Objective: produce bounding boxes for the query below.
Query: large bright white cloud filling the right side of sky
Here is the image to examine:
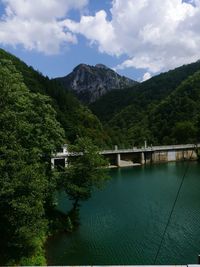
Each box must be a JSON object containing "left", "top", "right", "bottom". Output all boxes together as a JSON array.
[{"left": 63, "top": 0, "right": 200, "bottom": 74}]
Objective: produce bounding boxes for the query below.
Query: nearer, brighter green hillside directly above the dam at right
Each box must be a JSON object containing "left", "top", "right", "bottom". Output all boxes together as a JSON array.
[{"left": 107, "top": 71, "right": 200, "bottom": 147}]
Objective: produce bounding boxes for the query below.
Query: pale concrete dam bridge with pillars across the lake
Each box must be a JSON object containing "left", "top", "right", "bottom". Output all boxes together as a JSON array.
[{"left": 51, "top": 144, "right": 200, "bottom": 167}]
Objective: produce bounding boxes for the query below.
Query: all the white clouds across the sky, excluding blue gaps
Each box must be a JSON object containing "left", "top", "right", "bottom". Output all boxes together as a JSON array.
[{"left": 0, "top": 0, "right": 200, "bottom": 78}]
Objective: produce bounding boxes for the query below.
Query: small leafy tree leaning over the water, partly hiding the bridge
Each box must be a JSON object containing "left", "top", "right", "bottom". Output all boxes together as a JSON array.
[{"left": 62, "top": 138, "right": 108, "bottom": 228}]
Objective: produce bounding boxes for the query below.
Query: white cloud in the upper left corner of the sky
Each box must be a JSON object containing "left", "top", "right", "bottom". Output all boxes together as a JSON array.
[{"left": 0, "top": 0, "right": 88, "bottom": 54}]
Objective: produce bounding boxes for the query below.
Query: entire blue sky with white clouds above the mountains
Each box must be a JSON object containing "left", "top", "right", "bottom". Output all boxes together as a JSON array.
[{"left": 0, "top": 0, "right": 200, "bottom": 81}]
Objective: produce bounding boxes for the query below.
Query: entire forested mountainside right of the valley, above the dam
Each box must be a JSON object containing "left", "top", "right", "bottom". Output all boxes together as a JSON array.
[{"left": 90, "top": 61, "right": 200, "bottom": 147}]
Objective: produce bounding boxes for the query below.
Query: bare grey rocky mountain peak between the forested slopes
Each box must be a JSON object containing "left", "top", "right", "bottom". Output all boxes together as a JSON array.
[{"left": 56, "top": 64, "right": 137, "bottom": 104}]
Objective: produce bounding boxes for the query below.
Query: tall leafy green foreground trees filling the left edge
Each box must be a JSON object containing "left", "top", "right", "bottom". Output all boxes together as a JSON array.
[{"left": 0, "top": 59, "right": 64, "bottom": 265}]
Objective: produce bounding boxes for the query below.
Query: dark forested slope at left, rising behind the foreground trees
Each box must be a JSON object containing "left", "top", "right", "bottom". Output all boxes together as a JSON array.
[{"left": 0, "top": 49, "right": 109, "bottom": 146}]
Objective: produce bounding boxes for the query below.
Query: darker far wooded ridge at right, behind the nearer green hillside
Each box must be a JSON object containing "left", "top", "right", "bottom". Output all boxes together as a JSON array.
[{"left": 89, "top": 61, "right": 200, "bottom": 121}]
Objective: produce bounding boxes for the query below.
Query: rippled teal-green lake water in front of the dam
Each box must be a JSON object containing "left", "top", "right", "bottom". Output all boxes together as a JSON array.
[{"left": 47, "top": 162, "right": 200, "bottom": 265}]
